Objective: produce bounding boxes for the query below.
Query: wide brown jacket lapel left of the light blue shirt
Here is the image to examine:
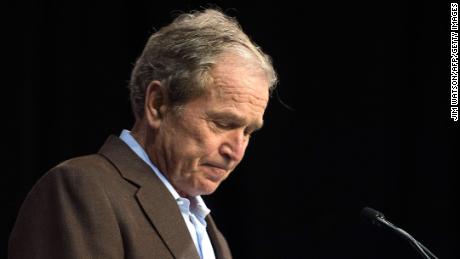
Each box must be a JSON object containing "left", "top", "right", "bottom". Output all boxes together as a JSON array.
[{"left": 99, "top": 136, "right": 199, "bottom": 259}]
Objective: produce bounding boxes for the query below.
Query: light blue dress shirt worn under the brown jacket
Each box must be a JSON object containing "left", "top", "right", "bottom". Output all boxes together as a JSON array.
[{"left": 120, "top": 130, "right": 216, "bottom": 259}]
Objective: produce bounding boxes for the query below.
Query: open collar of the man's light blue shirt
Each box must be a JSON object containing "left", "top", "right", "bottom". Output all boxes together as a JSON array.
[{"left": 120, "top": 129, "right": 211, "bottom": 221}]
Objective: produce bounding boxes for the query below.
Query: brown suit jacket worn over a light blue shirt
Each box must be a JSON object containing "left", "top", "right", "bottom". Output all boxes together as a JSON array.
[{"left": 8, "top": 136, "right": 231, "bottom": 259}]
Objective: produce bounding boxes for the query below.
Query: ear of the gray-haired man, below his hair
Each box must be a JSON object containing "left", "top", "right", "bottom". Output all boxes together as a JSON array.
[{"left": 144, "top": 80, "right": 168, "bottom": 129}]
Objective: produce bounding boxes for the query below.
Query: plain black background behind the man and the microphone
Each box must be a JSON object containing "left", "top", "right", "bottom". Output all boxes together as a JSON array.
[{"left": 0, "top": 0, "right": 460, "bottom": 258}]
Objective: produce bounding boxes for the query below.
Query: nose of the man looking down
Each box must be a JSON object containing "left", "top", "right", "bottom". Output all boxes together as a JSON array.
[{"left": 219, "top": 130, "right": 249, "bottom": 163}]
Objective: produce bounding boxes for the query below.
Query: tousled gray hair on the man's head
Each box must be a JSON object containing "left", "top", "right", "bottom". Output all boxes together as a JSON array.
[{"left": 129, "top": 9, "right": 277, "bottom": 118}]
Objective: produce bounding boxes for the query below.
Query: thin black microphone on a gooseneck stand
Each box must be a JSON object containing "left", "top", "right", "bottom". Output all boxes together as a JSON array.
[{"left": 361, "top": 207, "right": 439, "bottom": 259}]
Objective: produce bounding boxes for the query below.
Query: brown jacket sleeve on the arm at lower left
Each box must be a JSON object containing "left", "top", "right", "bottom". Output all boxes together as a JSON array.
[{"left": 8, "top": 164, "right": 124, "bottom": 259}]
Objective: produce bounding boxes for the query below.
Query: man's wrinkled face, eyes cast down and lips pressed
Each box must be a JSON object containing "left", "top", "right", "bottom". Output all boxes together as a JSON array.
[{"left": 149, "top": 55, "right": 269, "bottom": 196}]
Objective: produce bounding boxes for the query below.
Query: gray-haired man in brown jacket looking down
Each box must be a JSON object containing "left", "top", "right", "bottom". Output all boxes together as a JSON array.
[{"left": 9, "top": 10, "right": 276, "bottom": 259}]
